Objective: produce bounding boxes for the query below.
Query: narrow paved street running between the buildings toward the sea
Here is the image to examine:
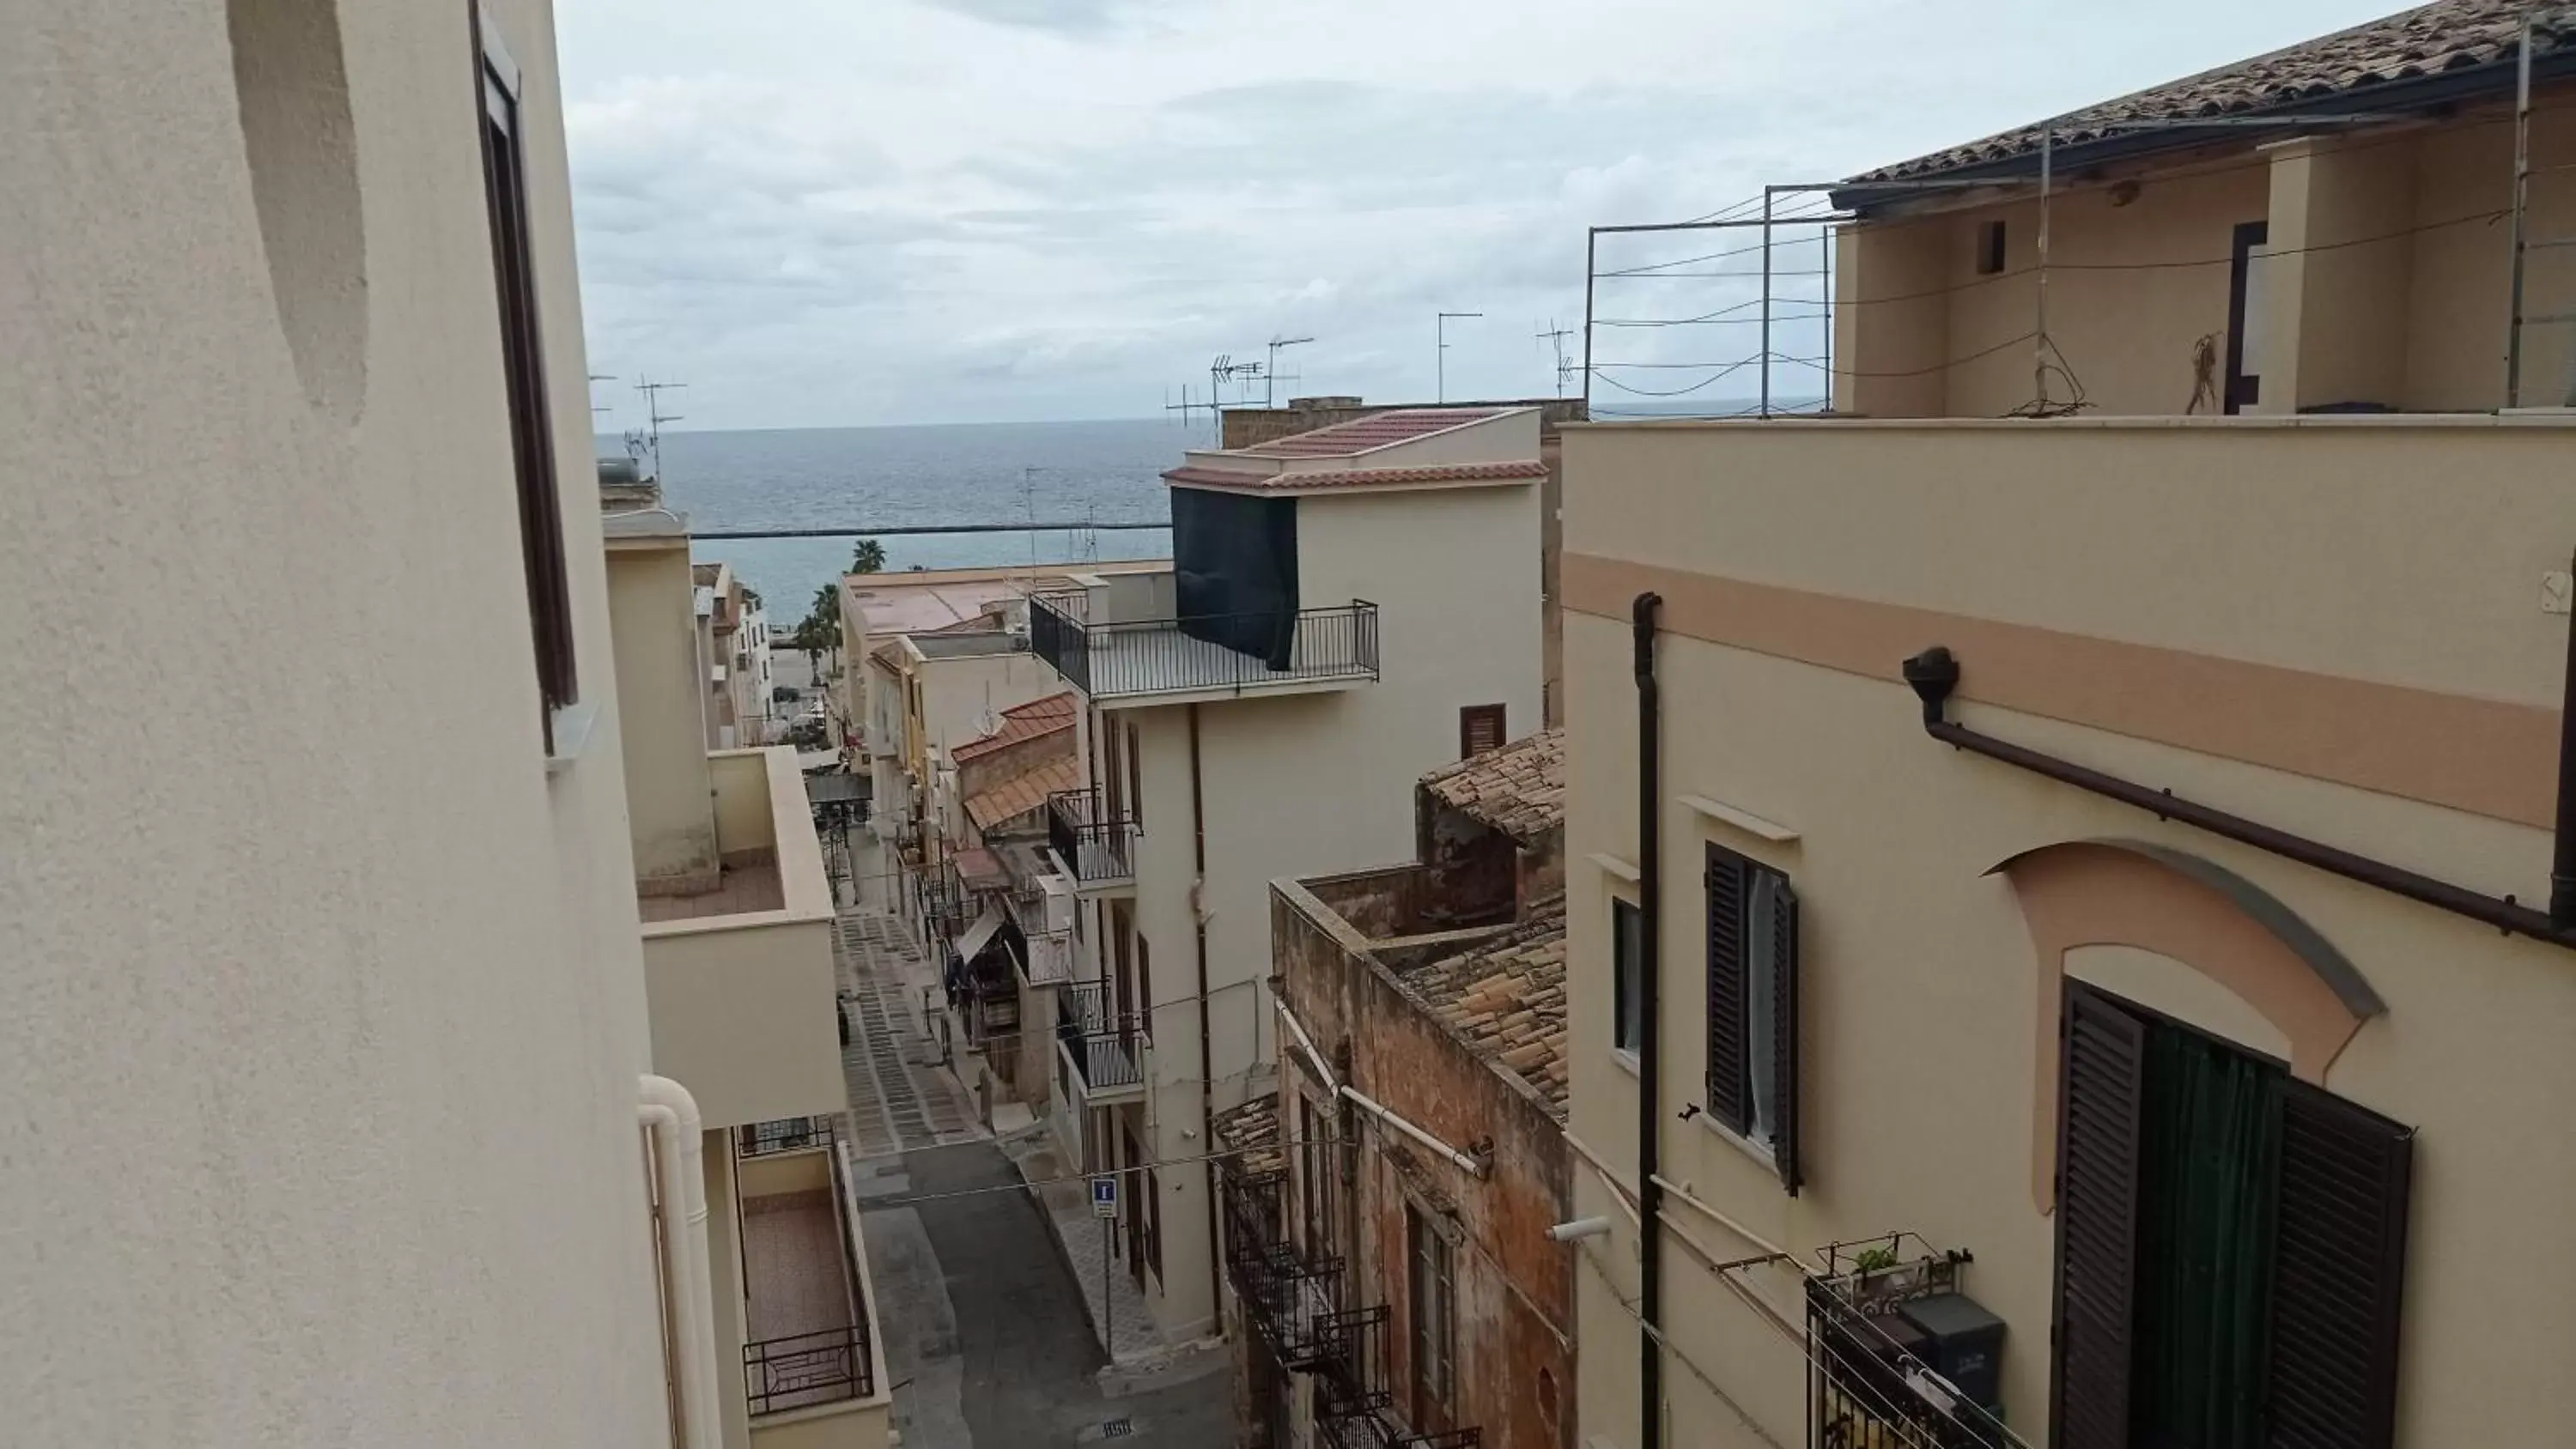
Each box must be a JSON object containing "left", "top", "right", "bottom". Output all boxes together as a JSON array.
[{"left": 837, "top": 911, "right": 1234, "bottom": 1449}]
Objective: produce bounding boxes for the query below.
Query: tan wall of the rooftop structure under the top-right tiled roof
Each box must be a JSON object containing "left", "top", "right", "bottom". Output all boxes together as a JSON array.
[{"left": 1834, "top": 88, "right": 2576, "bottom": 417}]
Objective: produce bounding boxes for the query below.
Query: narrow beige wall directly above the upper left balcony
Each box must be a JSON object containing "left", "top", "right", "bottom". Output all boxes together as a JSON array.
[{"left": 608, "top": 538, "right": 716, "bottom": 885}]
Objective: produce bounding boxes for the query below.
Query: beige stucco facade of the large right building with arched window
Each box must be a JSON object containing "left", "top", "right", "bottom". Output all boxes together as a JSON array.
[{"left": 1566, "top": 422, "right": 2576, "bottom": 1446}]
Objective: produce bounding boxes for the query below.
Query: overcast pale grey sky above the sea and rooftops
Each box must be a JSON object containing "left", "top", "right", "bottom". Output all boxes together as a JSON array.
[{"left": 556, "top": 0, "right": 2396, "bottom": 427}]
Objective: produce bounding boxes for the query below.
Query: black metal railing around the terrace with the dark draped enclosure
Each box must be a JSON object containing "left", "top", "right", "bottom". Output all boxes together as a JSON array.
[{"left": 1028, "top": 595, "right": 1378, "bottom": 700}]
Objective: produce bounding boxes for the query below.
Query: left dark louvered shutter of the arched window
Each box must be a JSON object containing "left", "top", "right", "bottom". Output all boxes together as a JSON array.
[{"left": 2048, "top": 980, "right": 2146, "bottom": 1449}]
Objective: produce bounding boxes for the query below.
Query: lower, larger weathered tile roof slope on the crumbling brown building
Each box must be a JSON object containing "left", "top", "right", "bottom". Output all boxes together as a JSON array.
[{"left": 1401, "top": 895, "right": 1569, "bottom": 1122}]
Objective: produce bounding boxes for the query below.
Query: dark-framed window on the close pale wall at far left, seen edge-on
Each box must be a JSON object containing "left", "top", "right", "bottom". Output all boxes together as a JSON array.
[{"left": 474, "top": 13, "right": 580, "bottom": 754}]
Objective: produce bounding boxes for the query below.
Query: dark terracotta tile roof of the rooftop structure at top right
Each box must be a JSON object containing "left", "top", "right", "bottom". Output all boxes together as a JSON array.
[{"left": 1852, "top": 0, "right": 2576, "bottom": 185}]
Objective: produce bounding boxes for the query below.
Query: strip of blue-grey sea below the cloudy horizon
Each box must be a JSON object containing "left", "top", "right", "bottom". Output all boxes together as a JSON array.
[{"left": 600, "top": 420, "right": 1208, "bottom": 628}]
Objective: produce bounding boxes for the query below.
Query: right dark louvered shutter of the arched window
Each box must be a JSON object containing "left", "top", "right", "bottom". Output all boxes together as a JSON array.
[{"left": 2269, "top": 1081, "right": 2414, "bottom": 1449}]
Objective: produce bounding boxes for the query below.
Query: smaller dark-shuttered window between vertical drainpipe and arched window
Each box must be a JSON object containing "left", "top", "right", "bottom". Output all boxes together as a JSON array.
[{"left": 1705, "top": 844, "right": 1801, "bottom": 1194}]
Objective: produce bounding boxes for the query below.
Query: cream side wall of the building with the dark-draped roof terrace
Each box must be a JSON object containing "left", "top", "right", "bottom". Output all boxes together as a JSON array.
[{"left": 1110, "top": 476, "right": 1540, "bottom": 1328}]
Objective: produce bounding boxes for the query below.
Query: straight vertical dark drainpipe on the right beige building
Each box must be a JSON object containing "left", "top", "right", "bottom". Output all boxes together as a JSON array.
[{"left": 1633, "top": 592, "right": 1664, "bottom": 1449}]
